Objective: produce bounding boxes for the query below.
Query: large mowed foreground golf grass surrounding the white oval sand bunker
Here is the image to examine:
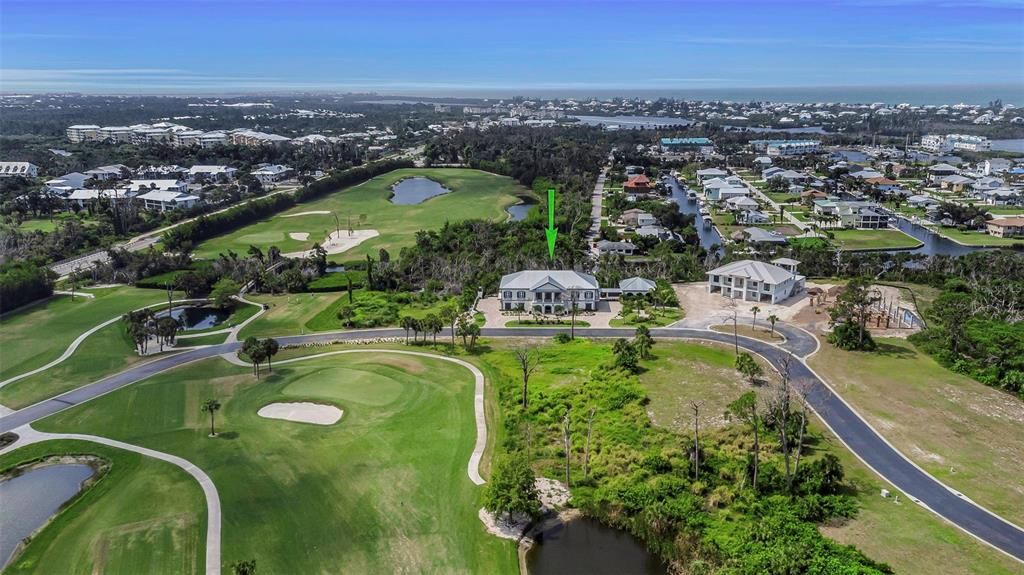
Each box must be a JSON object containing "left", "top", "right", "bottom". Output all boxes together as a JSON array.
[{"left": 38, "top": 352, "right": 518, "bottom": 573}]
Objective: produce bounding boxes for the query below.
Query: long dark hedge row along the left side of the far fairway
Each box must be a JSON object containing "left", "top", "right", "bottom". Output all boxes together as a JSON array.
[{"left": 164, "top": 161, "right": 413, "bottom": 250}]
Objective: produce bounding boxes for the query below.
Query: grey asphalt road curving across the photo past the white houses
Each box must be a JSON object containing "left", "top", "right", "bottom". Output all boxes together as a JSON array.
[{"left": 0, "top": 327, "right": 1024, "bottom": 562}]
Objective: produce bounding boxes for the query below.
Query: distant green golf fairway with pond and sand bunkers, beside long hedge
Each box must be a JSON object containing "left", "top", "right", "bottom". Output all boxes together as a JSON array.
[{"left": 196, "top": 168, "right": 532, "bottom": 259}]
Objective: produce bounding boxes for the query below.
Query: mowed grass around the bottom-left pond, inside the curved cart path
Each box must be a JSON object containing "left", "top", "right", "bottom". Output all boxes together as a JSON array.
[{"left": 0, "top": 440, "right": 206, "bottom": 575}]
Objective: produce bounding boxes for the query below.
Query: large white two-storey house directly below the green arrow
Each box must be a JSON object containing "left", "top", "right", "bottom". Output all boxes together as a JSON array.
[{"left": 498, "top": 270, "right": 601, "bottom": 314}]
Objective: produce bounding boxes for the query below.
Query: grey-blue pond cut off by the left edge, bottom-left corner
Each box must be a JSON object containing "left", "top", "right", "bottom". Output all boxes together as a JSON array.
[{"left": 0, "top": 463, "right": 94, "bottom": 565}]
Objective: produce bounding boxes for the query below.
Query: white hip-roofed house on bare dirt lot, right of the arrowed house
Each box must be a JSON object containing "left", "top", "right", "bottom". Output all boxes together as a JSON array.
[{"left": 708, "top": 258, "right": 805, "bottom": 304}]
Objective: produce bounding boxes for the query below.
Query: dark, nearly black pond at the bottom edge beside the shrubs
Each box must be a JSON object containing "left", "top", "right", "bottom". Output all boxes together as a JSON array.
[{"left": 526, "top": 519, "right": 668, "bottom": 575}]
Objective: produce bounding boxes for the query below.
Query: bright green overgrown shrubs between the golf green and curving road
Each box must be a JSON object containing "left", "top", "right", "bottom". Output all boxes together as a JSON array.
[{"left": 487, "top": 333, "right": 892, "bottom": 575}]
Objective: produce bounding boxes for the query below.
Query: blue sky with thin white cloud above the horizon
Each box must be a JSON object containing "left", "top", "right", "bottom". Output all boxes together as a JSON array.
[{"left": 0, "top": 0, "right": 1024, "bottom": 94}]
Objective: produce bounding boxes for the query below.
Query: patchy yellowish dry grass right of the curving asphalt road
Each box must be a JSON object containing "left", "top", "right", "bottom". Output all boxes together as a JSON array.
[{"left": 809, "top": 339, "right": 1024, "bottom": 525}]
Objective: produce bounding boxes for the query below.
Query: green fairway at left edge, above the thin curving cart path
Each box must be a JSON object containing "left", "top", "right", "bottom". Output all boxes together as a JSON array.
[{"left": 0, "top": 286, "right": 183, "bottom": 381}]
